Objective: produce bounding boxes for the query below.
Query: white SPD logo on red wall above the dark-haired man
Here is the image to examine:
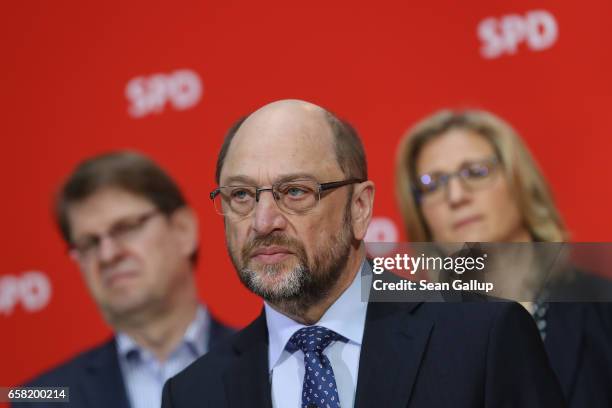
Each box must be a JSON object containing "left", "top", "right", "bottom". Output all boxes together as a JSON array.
[{"left": 125, "top": 69, "right": 203, "bottom": 118}]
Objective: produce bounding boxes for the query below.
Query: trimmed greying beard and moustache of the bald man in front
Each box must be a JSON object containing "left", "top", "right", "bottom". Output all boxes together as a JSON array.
[{"left": 228, "top": 201, "right": 354, "bottom": 315}]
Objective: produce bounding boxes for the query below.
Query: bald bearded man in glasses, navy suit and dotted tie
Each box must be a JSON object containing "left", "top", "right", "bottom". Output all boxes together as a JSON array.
[{"left": 162, "top": 100, "right": 564, "bottom": 408}]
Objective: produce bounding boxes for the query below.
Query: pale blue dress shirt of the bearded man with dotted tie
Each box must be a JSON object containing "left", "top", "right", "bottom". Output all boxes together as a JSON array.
[{"left": 264, "top": 261, "right": 368, "bottom": 408}]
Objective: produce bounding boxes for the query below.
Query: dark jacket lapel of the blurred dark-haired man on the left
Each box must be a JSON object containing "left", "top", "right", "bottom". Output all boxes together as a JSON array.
[{"left": 79, "top": 339, "right": 130, "bottom": 408}]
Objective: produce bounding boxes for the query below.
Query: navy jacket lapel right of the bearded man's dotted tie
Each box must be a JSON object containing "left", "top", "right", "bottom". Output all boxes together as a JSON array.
[{"left": 355, "top": 303, "right": 433, "bottom": 408}]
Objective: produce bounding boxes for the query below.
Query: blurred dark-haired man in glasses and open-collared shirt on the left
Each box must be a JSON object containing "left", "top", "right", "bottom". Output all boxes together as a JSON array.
[{"left": 18, "top": 152, "right": 231, "bottom": 408}]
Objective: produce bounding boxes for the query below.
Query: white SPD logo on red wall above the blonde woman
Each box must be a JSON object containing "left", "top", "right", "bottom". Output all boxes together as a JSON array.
[{"left": 478, "top": 10, "right": 559, "bottom": 59}]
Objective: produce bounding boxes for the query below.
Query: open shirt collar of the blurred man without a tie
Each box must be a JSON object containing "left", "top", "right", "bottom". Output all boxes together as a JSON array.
[{"left": 115, "top": 305, "right": 210, "bottom": 360}]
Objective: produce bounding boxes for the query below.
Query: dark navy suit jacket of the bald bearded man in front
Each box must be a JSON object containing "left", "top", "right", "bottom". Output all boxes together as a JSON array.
[{"left": 162, "top": 302, "right": 565, "bottom": 408}]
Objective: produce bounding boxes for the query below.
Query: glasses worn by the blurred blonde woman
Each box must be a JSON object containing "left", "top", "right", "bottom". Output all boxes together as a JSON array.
[{"left": 414, "top": 157, "right": 499, "bottom": 206}]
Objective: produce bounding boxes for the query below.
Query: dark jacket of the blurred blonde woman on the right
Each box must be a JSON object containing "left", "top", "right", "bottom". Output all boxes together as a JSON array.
[{"left": 426, "top": 256, "right": 612, "bottom": 408}]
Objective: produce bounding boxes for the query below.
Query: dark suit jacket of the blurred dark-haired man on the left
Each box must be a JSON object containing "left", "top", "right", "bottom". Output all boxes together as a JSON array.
[{"left": 13, "top": 317, "right": 234, "bottom": 408}]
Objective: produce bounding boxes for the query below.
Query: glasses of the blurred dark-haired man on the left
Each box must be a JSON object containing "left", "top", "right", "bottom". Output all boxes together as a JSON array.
[{"left": 70, "top": 209, "right": 161, "bottom": 262}]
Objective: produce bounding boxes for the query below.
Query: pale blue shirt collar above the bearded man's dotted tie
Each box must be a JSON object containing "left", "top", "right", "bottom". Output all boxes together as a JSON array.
[{"left": 264, "top": 260, "right": 368, "bottom": 371}]
